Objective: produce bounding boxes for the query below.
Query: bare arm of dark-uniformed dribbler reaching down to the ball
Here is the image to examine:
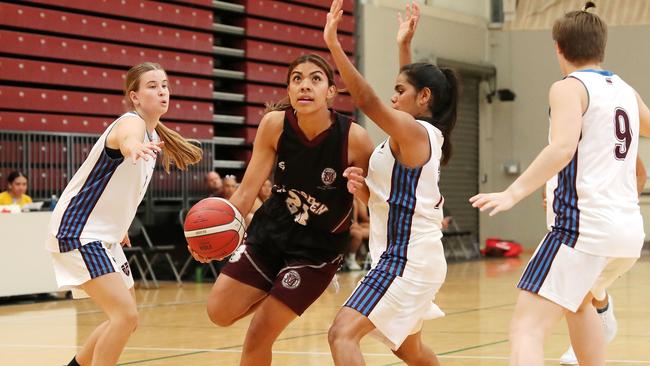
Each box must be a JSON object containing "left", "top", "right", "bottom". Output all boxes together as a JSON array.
[{"left": 230, "top": 111, "right": 284, "bottom": 217}]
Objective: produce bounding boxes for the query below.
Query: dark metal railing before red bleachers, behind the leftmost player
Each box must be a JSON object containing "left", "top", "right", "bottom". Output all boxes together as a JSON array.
[{"left": 0, "top": 131, "right": 214, "bottom": 207}]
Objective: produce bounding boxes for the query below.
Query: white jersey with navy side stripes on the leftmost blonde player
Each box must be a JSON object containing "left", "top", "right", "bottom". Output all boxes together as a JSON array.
[{"left": 46, "top": 113, "right": 158, "bottom": 253}]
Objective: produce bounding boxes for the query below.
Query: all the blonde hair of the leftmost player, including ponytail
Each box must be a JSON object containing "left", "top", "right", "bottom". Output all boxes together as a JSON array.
[{"left": 124, "top": 62, "right": 203, "bottom": 173}]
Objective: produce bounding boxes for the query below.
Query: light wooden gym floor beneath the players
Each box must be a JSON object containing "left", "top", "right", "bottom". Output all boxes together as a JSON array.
[{"left": 0, "top": 257, "right": 650, "bottom": 366}]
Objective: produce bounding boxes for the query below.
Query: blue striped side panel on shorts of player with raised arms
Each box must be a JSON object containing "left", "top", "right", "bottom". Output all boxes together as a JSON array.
[{"left": 344, "top": 269, "right": 397, "bottom": 316}]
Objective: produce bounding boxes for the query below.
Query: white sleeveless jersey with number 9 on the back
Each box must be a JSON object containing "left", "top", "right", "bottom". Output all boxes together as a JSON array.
[{"left": 546, "top": 70, "right": 645, "bottom": 257}]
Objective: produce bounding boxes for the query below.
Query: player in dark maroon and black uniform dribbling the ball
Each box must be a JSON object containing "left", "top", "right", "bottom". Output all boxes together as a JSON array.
[{"left": 187, "top": 55, "right": 373, "bottom": 366}]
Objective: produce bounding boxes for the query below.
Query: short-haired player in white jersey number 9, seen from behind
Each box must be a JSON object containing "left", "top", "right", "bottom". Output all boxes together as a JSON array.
[{"left": 470, "top": 2, "right": 650, "bottom": 366}]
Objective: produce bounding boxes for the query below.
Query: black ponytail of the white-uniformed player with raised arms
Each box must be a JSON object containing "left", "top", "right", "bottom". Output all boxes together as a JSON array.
[{"left": 433, "top": 68, "right": 460, "bottom": 165}]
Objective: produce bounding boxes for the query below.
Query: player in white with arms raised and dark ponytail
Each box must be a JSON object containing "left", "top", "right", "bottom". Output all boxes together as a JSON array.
[{"left": 324, "top": 0, "right": 458, "bottom": 366}]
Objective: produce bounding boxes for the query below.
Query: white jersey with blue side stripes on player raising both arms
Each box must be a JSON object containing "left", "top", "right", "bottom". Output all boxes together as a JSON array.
[{"left": 366, "top": 121, "right": 443, "bottom": 268}]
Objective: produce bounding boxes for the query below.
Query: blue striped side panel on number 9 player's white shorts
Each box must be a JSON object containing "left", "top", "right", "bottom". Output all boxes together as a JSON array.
[{"left": 517, "top": 231, "right": 563, "bottom": 294}]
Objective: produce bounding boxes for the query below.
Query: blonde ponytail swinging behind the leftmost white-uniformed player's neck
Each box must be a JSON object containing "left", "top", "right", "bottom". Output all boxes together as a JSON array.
[{"left": 156, "top": 122, "right": 203, "bottom": 173}]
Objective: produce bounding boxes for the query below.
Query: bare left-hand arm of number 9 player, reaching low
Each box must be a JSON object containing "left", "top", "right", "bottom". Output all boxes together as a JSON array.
[{"left": 469, "top": 78, "right": 587, "bottom": 216}]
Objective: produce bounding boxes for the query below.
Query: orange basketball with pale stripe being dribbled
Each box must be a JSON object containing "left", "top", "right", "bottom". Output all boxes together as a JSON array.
[{"left": 183, "top": 197, "right": 246, "bottom": 259}]
